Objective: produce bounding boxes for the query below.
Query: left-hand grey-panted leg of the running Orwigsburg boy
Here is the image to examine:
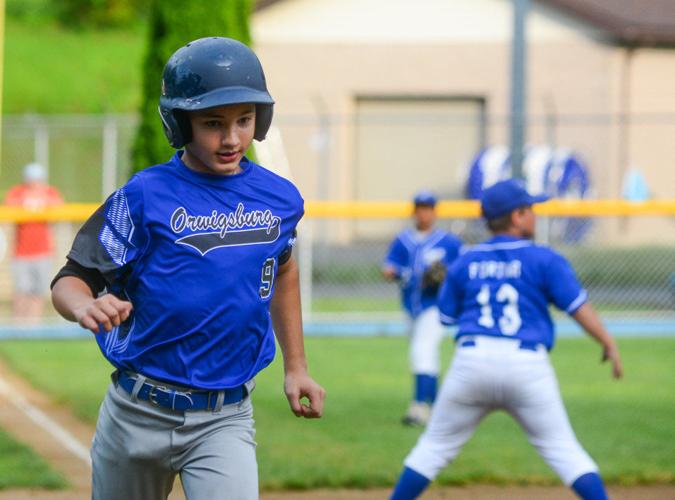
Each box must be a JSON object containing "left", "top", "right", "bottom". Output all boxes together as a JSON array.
[{"left": 91, "top": 385, "right": 177, "bottom": 500}]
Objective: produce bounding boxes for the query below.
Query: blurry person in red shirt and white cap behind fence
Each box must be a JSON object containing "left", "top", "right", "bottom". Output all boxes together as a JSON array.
[{"left": 5, "top": 163, "right": 63, "bottom": 318}]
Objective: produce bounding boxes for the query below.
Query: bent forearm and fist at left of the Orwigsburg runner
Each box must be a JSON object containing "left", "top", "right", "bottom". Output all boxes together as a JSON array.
[{"left": 52, "top": 276, "right": 132, "bottom": 333}]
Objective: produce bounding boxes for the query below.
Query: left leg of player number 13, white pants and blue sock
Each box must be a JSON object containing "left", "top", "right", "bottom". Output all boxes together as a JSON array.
[{"left": 391, "top": 355, "right": 489, "bottom": 500}]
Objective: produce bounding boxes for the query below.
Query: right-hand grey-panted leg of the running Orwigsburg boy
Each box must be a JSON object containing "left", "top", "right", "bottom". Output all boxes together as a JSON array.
[{"left": 174, "top": 397, "right": 258, "bottom": 500}]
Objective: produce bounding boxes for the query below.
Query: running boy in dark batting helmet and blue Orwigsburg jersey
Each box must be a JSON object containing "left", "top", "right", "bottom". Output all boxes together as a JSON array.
[{"left": 52, "top": 37, "right": 325, "bottom": 500}]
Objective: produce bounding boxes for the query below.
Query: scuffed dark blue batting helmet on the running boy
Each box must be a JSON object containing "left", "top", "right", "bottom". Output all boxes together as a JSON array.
[{"left": 159, "top": 37, "right": 274, "bottom": 149}]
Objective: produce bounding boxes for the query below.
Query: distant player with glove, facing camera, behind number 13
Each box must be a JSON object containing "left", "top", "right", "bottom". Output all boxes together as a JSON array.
[{"left": 382, "top": 191, "right": 462, "bottom": 425}]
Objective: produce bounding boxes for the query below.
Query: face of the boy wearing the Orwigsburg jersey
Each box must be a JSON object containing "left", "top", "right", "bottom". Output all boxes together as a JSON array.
[{"left": 183, "top": 104, "right": 255, "bottom": 175}]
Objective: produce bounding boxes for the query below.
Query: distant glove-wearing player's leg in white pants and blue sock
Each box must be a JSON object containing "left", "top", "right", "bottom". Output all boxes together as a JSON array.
[{"left": 403, "top": 307, "right": 443, "bottom": 425}]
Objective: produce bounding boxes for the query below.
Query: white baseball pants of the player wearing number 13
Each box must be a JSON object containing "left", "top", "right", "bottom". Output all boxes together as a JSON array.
[{"left": 405, "top": 335, "right": 598, "bottom": 485}]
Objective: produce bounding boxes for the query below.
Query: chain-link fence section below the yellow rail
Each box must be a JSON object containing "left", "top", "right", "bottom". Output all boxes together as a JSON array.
[{"left": 0, "top": 209, "right": 675, "bottom": 334}]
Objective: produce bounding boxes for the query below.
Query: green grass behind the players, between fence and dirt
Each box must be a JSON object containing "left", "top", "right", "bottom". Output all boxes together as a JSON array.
[{"left": 0, "top": 338, "right": 675, "bottom": 489}]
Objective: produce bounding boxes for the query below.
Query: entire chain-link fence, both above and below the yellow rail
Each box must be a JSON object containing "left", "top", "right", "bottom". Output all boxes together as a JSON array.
[{"left": 0, "top": 111, "right": 675, "bottom": 329}]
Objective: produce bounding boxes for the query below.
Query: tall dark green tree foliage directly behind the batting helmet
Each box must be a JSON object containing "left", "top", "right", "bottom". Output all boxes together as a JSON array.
[{"left": 131, "top": 0, "right": 252, "bottom": 172}]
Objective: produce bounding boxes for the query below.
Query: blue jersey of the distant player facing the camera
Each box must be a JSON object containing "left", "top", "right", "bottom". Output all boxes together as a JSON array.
[{"left": 384, "top": 228, "right": 462, "bottom": 318}]
